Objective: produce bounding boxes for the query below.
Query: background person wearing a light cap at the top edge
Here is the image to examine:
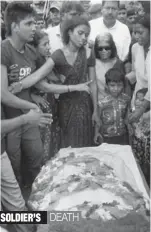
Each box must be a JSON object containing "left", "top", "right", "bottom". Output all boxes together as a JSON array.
[{"left": 47, "top": 1, "right": 61, "bottom": 28}]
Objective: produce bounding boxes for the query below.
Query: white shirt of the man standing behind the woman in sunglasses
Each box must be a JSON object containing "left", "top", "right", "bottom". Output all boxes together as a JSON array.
[{"left": 89, "top": 17, "right": 131, "bottom": 61}]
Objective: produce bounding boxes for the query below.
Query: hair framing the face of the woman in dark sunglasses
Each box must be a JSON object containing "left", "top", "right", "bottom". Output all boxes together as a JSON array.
[{"left": 94, "top": 33, "right": 117, "bottom": 59}]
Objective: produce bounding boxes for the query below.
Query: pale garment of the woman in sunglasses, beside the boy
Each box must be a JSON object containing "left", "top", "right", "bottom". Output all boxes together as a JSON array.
[{"left": 95, "top": 59, "right": 116, "bottom": 101}]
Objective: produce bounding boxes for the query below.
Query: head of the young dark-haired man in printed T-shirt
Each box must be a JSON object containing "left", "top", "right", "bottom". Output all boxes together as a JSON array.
[{"left": 4, "top": 2, "right": 36, "bottom": 42}]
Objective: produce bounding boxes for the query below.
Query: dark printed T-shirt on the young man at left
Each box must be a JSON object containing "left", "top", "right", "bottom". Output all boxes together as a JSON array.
[{"left": 1, "top": 39, "right": 37, "bottom": 118}]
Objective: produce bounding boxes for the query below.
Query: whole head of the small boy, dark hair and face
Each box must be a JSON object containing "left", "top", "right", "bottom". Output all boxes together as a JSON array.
[{"left": 105, "top": 68, "right": 125, "bottom": 98}]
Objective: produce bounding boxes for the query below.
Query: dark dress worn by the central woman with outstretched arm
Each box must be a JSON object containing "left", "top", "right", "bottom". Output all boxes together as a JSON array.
[{"left": 52, "top": 48, "right": 95, "bottom": 147}]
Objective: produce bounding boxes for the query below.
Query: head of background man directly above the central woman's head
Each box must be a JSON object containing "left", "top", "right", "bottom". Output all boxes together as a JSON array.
[{"left": 60, "top": 1, "right": 85, "bottom": 21}]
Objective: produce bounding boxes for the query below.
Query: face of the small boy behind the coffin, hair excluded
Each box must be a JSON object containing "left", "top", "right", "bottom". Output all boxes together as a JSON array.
[{"left": 107, "top": 81, "right": 124, "bottom": 97}]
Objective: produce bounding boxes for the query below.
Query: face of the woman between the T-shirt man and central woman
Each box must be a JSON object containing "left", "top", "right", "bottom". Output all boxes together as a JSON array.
[{"left": 38, "top": 35, "right": 50, "bottom": 57}]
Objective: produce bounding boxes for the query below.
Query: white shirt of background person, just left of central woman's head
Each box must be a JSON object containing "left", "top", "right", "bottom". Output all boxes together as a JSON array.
[{"left": 45, "top": 24, "right": 63, "bottom": 53}]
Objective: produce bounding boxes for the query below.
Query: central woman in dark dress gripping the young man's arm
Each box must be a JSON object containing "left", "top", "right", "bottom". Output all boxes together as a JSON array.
[{"left": 10, "top": 16, "right": 98, "bottom": 147}]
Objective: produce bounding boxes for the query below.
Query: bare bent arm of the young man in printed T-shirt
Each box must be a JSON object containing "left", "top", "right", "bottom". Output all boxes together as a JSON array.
[{"left": 1, "top": 65, "right": 38, "bottom": 109}]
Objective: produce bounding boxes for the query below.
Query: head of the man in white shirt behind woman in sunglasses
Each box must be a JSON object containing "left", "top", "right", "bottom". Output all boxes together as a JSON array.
[{"left": 102, "top": 0, "right": 119, "bottom": 24}]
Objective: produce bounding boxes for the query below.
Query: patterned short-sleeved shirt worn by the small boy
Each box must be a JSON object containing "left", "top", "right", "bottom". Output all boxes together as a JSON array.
[{"left": 99, "top": 93, "right": 130, "bottom": 138}]
